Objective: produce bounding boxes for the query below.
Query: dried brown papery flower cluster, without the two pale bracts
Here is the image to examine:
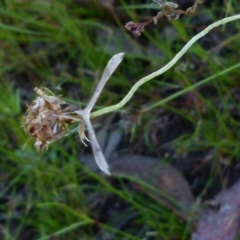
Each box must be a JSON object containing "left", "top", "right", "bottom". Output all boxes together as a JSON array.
[{"left": 23, "top": 87, "right": 73, "bottom": 151}]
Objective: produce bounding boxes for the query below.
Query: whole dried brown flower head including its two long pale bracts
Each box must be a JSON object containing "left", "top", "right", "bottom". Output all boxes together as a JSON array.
[{"left": 22, "top": 53, "right": 124, "bottom": 174}]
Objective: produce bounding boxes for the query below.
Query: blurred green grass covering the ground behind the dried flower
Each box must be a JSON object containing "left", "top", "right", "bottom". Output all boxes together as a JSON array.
[{"left": 0, "top": 0, "right": 240, "bottom": 240}]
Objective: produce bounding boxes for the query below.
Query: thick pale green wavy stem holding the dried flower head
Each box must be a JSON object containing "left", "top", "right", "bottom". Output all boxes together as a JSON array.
[{"left": 91, "top": 14, "right": 240, "bottom": 118}]
